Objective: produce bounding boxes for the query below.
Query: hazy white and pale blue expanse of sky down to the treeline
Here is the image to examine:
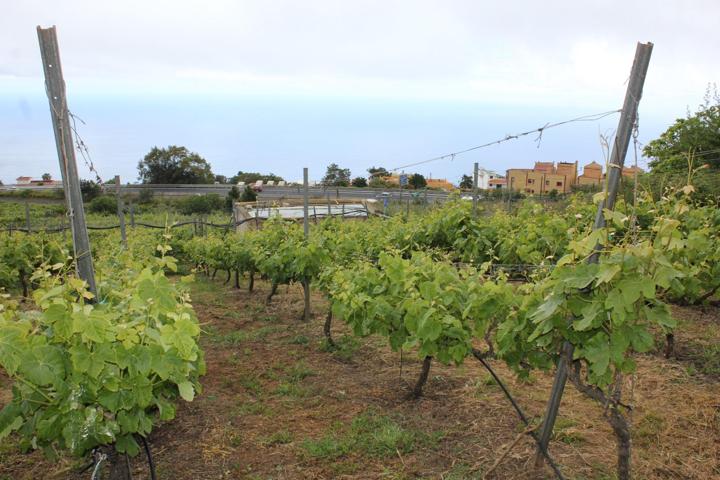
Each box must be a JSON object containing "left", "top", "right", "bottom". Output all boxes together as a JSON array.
[{"left": 0, "top": 0, "right": 720, "bottom": 184}]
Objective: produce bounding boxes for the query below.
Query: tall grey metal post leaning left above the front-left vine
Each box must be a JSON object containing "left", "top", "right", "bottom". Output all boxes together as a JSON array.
[{"left": 37, "top": 26, "right": 97, "bottom": 298}]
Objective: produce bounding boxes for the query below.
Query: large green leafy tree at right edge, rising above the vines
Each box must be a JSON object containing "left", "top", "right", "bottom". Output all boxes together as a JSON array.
[{"left": 643, "top": 87, "right": 720, "bottom": 174}]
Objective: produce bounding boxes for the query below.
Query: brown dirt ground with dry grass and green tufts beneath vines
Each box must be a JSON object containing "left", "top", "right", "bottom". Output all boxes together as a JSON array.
[{"left": 0, "top": 277, "right": 720, "bottom": 480}]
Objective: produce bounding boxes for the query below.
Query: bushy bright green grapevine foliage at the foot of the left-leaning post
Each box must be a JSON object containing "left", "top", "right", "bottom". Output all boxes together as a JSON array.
[{"left": 0, "top": 247, "right": 205, "bottom": 455}]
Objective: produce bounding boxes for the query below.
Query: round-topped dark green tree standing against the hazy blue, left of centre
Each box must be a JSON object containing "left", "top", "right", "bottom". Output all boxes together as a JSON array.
[{"left": 138, "top": 145, "right": 215, "bottom": 184}]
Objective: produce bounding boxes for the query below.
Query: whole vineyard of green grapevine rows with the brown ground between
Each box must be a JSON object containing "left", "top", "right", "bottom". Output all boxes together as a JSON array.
[{"left": 0, "top": 186, "right": 720, "bottom": 478}]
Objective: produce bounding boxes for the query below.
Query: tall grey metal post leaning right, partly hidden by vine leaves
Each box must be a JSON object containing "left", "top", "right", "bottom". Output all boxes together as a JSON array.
[{"left": 536, "top": 42, "right": 653, "bottom": 465}]
